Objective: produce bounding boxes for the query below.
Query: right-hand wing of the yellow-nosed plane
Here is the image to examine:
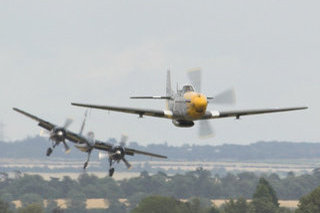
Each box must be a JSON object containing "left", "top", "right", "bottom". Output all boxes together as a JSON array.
[{"left": 203, "top": 107, "right": 308, "bottom": 119}]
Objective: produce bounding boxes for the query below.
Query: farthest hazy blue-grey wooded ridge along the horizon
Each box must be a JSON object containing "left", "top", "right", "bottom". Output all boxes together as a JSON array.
[{"left": 0, "top": 137, "right": 320, "bottom": 161}]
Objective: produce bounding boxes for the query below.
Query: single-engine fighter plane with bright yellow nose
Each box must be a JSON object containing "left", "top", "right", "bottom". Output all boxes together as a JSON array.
[{"left": 72, "top": 68, "right": 307, "bottom": 137}]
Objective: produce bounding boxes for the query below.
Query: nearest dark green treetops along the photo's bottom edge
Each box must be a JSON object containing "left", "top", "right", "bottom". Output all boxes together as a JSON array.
[{"left": 0, "top": 177, "right": 320, "bottom": 213}]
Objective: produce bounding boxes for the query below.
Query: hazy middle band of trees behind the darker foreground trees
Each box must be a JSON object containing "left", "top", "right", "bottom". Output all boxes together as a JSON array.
[{"left": 0, "top": 168, "right": 320, "bottom": 212}]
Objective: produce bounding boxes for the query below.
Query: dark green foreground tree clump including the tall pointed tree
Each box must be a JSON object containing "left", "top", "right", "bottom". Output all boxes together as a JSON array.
[{"left": 132, "top": 178, "right": 294, "bottom": 213}]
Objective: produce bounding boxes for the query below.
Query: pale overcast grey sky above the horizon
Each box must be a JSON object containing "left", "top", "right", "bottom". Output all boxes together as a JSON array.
[{"left": 0, "top": 0, "right": 320, "bottom": 145}]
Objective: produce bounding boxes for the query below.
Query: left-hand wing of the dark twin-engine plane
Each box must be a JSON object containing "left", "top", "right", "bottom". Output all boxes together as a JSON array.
[{"left": 13, "top": 108, "right": 87, "bottom": 143}]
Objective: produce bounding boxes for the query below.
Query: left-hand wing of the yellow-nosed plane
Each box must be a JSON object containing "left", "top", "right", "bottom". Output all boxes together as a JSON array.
[{"left": 71, "top": 103, "right": 172, "bottom": 118}]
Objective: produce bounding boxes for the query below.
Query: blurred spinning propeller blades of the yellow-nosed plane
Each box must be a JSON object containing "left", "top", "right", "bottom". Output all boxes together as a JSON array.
[{"left": 188, "top": 68, "right": 236, "bottom": 138}]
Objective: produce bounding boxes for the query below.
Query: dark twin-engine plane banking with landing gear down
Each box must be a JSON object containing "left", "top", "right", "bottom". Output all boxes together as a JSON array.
[{"left": 13, "top": 108, "right": 167, "bottom": 176}]
